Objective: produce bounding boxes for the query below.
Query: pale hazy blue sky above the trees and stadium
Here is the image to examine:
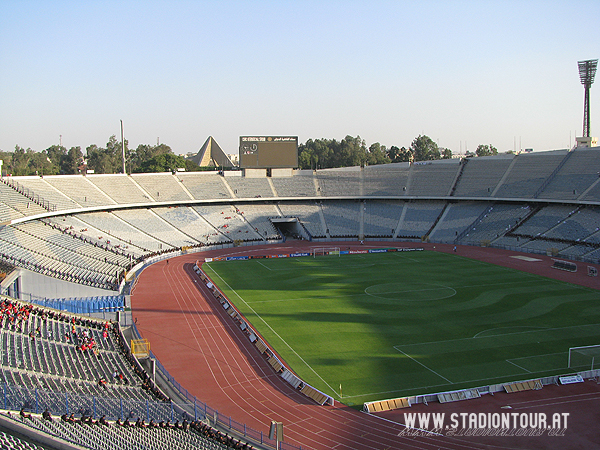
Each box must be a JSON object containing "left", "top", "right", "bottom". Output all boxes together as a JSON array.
[{"left": 0, "top": 0, "right": 600, "bottom": 158}]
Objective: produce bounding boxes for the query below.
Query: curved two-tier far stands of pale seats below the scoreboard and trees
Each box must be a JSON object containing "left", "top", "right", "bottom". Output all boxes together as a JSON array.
[{"left": 0, "top": 149, "right": 600, "bottom": 298}]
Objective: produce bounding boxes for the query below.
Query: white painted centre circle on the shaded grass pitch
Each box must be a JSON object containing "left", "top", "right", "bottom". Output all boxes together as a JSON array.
[{"left": 365, "top": 281, "right": 456, "bottom": 302}]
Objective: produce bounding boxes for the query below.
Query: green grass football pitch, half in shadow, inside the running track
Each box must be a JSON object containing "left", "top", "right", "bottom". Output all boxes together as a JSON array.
[{"left": 203, "top": 251, "right": 600, "bottom": 405}]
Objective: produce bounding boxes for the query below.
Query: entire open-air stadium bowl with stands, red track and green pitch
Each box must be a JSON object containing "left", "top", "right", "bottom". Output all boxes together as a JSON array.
[{"left": 0, "top": 147, "right": 600, "bottom": 449}]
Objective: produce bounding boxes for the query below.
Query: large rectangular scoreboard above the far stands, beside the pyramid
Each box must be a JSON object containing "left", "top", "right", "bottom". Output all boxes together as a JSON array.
[{"left": 240, "top": 136, "right": 298, "bottom": 169}]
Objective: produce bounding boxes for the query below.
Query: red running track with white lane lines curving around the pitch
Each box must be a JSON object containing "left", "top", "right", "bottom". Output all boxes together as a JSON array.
[{"left": 131, "top": 242, "right": 598, "bottom": 450}]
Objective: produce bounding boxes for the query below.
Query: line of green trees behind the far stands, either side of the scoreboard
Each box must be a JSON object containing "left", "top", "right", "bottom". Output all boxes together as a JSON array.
[{"left": 0, "top": 135, "right": 498, "bottom": 176}]
